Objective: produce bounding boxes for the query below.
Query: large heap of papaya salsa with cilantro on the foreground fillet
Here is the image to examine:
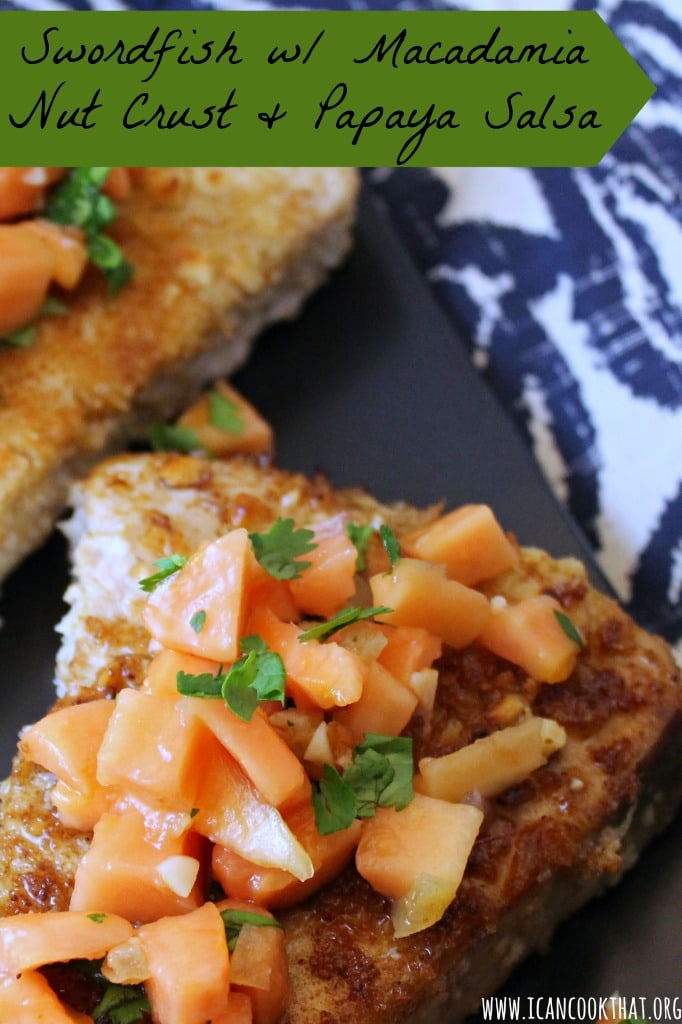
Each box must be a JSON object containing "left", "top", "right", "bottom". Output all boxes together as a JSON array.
[{"left": 0, "top": 505, "right": 582, "bottom": 1024}]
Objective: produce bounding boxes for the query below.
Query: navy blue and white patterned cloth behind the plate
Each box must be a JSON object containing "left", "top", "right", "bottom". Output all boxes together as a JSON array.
[{"left": 6, "top": 0, "right": 682, "bottom": 658}]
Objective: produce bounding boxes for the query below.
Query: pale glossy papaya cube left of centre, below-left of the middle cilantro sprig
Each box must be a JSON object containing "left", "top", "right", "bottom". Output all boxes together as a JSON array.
[{"left": 97, "top": 689, "right": 207, "bottom": 810}]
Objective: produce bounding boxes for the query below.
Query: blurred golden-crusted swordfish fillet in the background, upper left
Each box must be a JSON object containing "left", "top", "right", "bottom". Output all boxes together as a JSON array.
[{"left": 0, "top": 167, "right": 357, "bottom": 580}]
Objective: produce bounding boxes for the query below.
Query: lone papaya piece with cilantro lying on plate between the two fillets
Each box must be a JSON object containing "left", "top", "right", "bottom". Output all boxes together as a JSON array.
[{"left": 178, "top": 381, "right": 273, "bottom": 458}]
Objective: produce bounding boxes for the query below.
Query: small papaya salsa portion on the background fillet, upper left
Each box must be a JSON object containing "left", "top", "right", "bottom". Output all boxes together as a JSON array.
[{"left": 0, "top": 167, "right": 131, "bottom": 347}]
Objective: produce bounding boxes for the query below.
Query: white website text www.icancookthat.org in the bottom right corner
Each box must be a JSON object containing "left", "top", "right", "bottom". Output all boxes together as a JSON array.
[{"left": 481, "top": 995, "right": 682, "bottom": 1024}]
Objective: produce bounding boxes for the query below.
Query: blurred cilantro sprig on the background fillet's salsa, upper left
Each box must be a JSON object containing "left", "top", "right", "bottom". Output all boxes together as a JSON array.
[{"left": 44, "top": 167, "right": 132, "bottom": 293}]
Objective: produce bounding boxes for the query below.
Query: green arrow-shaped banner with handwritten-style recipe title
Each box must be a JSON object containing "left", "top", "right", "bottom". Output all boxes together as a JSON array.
[{"left": 0, "top": 11, "right": 654, "bottom": 167}]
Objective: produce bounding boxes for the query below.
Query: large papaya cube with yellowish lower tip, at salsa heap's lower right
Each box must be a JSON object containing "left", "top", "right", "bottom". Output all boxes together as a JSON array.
[{"left": 355, "top": 794, "right": 483, "bottom": 935}]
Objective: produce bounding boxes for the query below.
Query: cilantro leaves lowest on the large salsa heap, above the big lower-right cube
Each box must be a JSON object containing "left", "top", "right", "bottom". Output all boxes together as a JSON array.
[{"left": 312, "top": 733, "right": 414, "bottom": 836}]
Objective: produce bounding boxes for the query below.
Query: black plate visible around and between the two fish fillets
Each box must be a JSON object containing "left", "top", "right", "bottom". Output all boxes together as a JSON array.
[{"left": 0, "top": 192, "right": 682, "bottom": 1020}]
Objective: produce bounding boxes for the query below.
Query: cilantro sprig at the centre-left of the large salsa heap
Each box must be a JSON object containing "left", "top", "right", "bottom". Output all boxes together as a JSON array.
[{"left": 176, "top": 634, "right": 287, "bottom": 722}]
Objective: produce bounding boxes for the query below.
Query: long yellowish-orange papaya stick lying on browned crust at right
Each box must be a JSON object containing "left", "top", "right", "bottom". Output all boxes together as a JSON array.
[{"left": 415, "top": 717, "right": 566, "bottom": 802}]
